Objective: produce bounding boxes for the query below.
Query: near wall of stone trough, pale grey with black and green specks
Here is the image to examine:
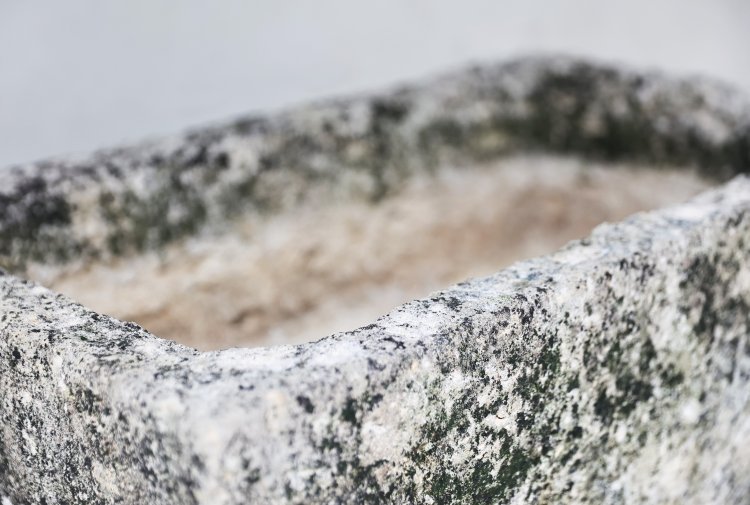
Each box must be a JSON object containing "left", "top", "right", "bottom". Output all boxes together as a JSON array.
[{"left": 0, "top": 178, "right": 750, "bottom": 504}]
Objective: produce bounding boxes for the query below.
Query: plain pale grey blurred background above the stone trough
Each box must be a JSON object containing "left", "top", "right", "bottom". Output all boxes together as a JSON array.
[{"left": 0, "top": 0, "right": 750, "bottom": 166}]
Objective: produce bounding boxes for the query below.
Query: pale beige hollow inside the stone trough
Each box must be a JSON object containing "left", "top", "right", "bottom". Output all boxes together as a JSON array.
[{"left": 36, "top": 157, "right": 710, "bottom": 349}]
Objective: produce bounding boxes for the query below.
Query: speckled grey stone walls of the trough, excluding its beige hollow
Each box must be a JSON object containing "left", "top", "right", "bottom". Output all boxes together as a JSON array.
[{"left": 0, "top": 59, "right": 750, "bottom": 505}]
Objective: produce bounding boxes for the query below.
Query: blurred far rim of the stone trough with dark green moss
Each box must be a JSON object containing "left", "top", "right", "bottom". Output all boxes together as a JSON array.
[{"left": 0, "top": 57, "right": 750, "bottom": 272}]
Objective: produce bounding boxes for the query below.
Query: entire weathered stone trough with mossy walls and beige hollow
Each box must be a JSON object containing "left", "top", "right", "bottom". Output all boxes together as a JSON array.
[{"left": 0, "top": 57, "right": 750, "bottom": 505}]
